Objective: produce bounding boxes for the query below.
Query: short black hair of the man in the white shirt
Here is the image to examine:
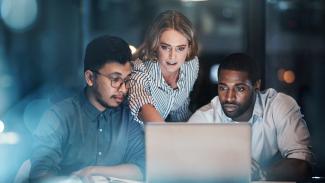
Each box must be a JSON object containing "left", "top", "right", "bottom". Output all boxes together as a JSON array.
[{"left": 218, "top": 53, "right": 261, "bottom": 84}]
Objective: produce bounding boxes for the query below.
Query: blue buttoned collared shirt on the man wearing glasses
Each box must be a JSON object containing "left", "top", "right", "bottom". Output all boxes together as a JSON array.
[{"left": 30, "top": 92, "right": 144, "bottom": 179}]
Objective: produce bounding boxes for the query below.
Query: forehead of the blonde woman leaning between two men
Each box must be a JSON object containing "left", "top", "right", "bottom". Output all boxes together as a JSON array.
[{"left": 159, "top": 29, "right": 188, "bottom": 46}]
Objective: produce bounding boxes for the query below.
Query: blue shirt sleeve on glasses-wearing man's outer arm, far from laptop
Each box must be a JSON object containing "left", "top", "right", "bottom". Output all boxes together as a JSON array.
[{"left": 30, "top": 109, "right": 67, "bottom": 180}]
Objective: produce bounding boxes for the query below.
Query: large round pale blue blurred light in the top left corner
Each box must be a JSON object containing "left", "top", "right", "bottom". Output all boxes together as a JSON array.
[{"left": 0, "top": 0, "right": 38, "bottom": 31}]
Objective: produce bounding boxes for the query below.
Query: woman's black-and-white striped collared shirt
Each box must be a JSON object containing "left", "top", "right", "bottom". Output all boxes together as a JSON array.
[{"left": 129, "top": 57, "right": 199, "bottom": 123}]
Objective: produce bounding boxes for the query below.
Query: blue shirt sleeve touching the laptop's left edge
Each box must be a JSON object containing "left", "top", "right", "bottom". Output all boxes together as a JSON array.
[{"left": 126, "top": 118, "right": 145, "bottom": 175}]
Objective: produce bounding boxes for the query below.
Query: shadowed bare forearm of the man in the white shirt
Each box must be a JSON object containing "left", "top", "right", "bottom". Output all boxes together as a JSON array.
[{"left": 265, "top": 158, "right": 312, "bottom": 181}]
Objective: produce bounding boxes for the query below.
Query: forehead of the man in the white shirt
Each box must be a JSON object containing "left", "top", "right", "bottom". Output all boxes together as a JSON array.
[{"left": 219, "top": 69, "right": 251, "bottom": 84}]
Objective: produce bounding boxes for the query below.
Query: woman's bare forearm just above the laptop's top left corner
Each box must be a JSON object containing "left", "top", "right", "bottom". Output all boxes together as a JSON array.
[{"left": 138, "top": 104, "right": 165, "bottom": 122}]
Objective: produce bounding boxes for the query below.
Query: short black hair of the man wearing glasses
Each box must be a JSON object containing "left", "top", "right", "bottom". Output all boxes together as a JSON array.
[{"left": 84, "top": 35, "right": 132, "bottom": 71}]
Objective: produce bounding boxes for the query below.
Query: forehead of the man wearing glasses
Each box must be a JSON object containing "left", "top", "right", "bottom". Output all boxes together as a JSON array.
[{"left": 99, "top": 62, "right": 132, "bottom": 77}]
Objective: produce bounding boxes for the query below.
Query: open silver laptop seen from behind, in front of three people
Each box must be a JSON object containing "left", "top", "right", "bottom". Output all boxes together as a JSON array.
[{"left": 145, "top": 122, "right": 251, "bottom": 183}]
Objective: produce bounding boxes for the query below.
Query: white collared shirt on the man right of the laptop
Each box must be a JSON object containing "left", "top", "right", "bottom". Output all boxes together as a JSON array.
[{"left": 189, "top": 89, "right": 313, "bottom": 166}]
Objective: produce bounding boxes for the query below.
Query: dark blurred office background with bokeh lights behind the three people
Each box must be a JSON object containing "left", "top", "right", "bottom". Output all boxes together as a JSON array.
[{"left": 0, "top": 0, "right": 325, "bottom": 182}]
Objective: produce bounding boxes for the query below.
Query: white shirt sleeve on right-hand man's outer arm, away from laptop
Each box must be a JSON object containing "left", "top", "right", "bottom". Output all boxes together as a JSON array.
[{"left": 273, "top": 93, "right": 314, "bottom": 163}]
